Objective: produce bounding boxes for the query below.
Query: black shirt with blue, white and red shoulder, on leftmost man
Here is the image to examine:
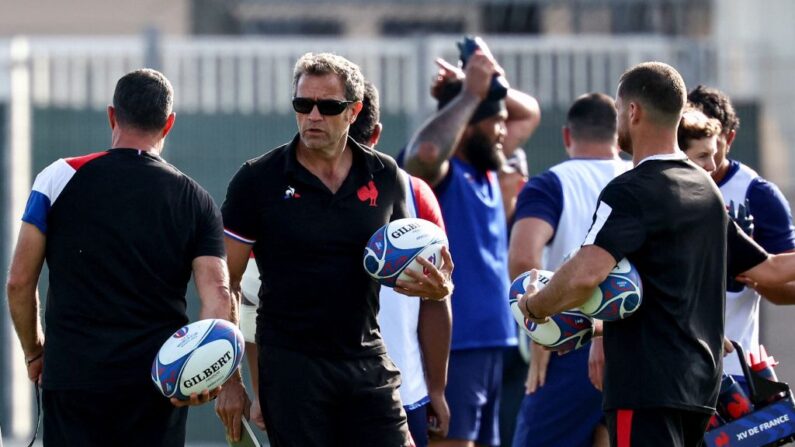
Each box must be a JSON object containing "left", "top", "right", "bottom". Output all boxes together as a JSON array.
[{"left": 22, "top": 149, "right": 225, "bottom": 390}]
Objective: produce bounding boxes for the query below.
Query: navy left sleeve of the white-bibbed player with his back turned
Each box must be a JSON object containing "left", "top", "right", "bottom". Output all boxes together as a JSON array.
[{"left": 514, "top": 171, "right": 563, "bottom": 230}]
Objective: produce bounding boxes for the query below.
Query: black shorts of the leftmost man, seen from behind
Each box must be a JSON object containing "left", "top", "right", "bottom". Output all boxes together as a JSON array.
[{"left": 41, "top": 383, "right": 188, "bottom": 447}]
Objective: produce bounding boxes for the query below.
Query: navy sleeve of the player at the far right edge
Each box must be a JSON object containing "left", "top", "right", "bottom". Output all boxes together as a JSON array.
[{"left": 746, "top": 178, "right": 795, "bottom": 253}]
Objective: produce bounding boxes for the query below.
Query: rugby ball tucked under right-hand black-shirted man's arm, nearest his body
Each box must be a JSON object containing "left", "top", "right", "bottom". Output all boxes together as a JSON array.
[{"left": 580, "top": 258, "right": 643, "bottom": 321}]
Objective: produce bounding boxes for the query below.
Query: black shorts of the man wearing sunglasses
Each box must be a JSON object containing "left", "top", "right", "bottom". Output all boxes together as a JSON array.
[{"left": 259, "top": 346, "right": 409, "bottom": 447}]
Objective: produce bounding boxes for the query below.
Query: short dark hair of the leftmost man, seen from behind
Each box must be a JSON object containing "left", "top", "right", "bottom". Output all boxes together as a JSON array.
[{"left": 113, "top": 68, "right": 174, "bottom": 132}]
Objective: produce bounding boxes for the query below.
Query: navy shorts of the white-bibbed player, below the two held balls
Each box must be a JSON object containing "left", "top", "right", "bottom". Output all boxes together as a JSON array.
[{"left": 513, "top": 345, "right": 604, "bottom": 447}]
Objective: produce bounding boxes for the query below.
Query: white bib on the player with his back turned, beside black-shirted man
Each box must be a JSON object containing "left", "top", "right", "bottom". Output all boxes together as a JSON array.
[{"left": 544, "top": 159, "right": 632, "bottom": 272}]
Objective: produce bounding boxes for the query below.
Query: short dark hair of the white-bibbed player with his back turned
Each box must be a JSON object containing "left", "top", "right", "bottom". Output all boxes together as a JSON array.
[{"left": 566, "top": 93, "right": 616, "bottom": 142}]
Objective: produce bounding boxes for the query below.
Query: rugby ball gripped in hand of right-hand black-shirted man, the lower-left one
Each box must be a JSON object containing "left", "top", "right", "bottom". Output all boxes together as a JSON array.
[{"left": 509, "top": 270, "right": 593, "bottom": 351}]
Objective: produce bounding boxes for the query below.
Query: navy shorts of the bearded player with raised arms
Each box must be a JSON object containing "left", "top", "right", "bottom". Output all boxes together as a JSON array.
[{"left": 444, "top": 348, "right": 505, "bottom": 446}]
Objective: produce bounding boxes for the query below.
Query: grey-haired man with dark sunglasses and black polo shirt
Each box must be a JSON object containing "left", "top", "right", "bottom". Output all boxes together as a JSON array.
[{"left": 222, "top": 53, "right": 409, "bottom": 446}]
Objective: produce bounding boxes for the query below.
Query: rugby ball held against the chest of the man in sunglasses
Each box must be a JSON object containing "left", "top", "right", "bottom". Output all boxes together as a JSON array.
[{"left": 364, "top": 217, "right": 448, "bottom": 287}]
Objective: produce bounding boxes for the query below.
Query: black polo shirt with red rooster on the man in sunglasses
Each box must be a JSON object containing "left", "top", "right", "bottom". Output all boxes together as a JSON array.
[{"left": 222, "top": 136, "right": 407, "bottom": 357}]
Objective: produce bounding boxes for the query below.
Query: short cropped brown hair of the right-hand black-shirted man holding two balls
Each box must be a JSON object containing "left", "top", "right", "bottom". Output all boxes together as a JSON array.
[{"left": 618, "top": 62, "right": 687, "bottom": 125}]
